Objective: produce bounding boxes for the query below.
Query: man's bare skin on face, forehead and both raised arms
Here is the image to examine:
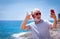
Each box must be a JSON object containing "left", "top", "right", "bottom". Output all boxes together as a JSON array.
[{"left": 21, "top": 10, "right": 57, "bottom": 30}]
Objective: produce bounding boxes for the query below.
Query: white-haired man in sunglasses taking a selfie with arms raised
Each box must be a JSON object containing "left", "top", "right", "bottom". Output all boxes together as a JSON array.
[{"left": 21, "top": 9, "right": 57, "bottom": 39}]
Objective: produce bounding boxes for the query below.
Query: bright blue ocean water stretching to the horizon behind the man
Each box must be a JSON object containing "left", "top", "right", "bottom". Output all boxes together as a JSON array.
[{"left": 0, "top": 20, "right": 53, "bottom": 39}]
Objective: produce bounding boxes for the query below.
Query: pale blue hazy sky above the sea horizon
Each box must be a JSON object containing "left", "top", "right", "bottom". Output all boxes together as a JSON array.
[{"left": 0, "top": 0, "right": 60, "bottom": 20}]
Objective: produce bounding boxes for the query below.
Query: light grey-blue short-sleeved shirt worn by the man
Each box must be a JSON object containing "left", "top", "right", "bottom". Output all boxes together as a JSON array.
[{"left": 27, "top": 19, "right": 51, "bottom": 39}]
